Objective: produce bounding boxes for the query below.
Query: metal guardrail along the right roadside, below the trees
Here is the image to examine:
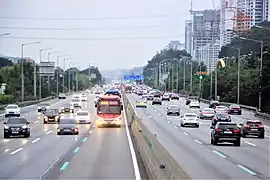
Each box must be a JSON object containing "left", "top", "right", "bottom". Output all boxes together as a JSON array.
[{"left": 179, "top": 94, "right": 270, "bottom": 119}]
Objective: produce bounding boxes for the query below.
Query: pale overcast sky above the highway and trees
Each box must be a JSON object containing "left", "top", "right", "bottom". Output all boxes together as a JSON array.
[{"left": 0, "top": 0, "right": 219, "bottom": 70}]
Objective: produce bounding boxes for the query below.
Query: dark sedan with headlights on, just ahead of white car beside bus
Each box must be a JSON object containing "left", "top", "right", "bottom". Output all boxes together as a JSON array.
[{"left": 57, "top": 117, "right": 79, "bottom": 135}]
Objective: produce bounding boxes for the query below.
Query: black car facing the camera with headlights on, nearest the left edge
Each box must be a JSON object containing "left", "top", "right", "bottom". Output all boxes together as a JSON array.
[{"left": 4, "top": 117, "right": 30, "bottom": 138}]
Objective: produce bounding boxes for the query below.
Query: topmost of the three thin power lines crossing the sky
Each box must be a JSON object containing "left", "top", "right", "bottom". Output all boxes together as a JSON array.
[{"left": 0, "top": 13, "right": 179, "bottom": 20}]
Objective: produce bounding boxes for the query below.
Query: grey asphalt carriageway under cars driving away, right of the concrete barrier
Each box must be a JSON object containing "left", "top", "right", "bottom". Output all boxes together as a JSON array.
[{"left": 128, "top": 94, "right": 270, "bottom": 179}]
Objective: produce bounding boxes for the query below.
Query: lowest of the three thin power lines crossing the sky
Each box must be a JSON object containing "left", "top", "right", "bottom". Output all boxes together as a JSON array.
[{"left": 3, "top": 35, "right": 183, "bottom": 41}]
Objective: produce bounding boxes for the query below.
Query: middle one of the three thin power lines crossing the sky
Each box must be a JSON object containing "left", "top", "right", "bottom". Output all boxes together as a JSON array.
[{"left": 0, "top": 24, "right": 180, "bottom": 31}]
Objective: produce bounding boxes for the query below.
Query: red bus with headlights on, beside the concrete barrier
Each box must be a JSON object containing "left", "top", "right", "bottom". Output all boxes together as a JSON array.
[{"left": 96, "top": 95, "right": 123, "bottom": 127}]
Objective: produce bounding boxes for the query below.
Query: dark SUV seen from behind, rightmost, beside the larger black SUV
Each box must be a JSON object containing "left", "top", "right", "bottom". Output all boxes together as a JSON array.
[{"left": 240, "top": 120, "right": 265, "bottom": 139}]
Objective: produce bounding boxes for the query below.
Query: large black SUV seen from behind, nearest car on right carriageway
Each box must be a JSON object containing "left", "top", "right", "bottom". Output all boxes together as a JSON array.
[{"left": 211, "top": 122, "right": 241, "bottom": 146}]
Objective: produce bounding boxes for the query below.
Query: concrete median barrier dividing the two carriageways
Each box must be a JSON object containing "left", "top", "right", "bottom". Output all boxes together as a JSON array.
[{"left": 123, "top": 93, "right": 191, "bottom": 179}]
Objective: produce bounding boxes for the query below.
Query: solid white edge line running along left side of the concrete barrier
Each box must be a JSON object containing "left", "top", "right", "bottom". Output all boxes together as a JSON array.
[{"left": 123, "top": 94, "right": 141, "bottom": 180}]
